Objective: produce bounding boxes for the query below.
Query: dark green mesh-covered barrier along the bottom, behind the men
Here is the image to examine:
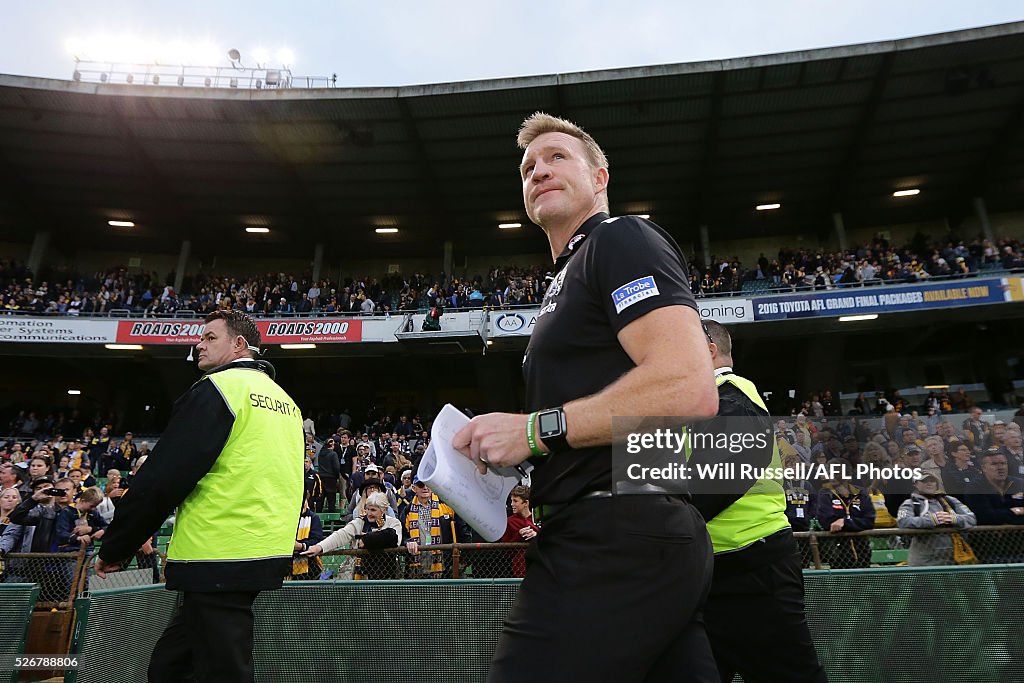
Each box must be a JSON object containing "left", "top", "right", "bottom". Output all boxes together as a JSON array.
[{"left": 59, "top": 565, "right": 1024, "bottom": 683}]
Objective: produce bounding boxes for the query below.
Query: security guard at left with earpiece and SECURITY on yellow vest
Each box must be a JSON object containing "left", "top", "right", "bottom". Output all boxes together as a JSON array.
[{"left": 96, "top": 310, "right": 304, "bottom": 683}]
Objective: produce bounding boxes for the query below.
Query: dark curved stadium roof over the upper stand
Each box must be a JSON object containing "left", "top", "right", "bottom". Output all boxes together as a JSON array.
[{"left": 0, "top": 23, "right": 1024, "bottom": 258}]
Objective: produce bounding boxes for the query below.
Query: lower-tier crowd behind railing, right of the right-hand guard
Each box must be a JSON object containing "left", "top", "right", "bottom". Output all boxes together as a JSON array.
[{"left": 775, "top": 403, "right": 1024, "bottom": 567}]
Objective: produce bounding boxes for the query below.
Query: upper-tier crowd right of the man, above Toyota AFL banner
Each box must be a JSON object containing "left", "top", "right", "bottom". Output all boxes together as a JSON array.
[{"left": 690, "top": 236, "right": 1024, "bottom": 297}]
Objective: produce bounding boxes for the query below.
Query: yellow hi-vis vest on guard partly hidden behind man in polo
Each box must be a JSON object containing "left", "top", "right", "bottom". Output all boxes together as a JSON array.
[{"left": 708, "top": 373, "right": 790, "bottom": 554}]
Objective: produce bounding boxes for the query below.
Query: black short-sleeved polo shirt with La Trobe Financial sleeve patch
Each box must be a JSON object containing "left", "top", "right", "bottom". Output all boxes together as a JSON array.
[{"left": 523, "top": 213, "right": 696, "bottom": 504}]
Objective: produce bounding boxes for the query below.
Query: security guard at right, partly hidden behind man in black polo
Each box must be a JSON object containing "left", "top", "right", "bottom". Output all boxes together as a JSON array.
[{"left": 689, "top": 321, "right": 827, "bottom": 683}]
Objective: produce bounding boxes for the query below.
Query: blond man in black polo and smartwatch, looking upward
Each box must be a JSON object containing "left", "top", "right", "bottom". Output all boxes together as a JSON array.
[{"left": 453, "top": 113, "right": 718, "bottom": 683}]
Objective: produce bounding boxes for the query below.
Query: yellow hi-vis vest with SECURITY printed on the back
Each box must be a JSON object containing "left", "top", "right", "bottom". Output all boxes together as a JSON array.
[{"left": 167, "top": 368, "right": 305, "bottom": 561}]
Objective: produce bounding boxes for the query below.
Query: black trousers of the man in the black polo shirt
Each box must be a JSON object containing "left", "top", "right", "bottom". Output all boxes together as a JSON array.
[{"left": 487, "top": 496, "right": 718, "bottom": 683}]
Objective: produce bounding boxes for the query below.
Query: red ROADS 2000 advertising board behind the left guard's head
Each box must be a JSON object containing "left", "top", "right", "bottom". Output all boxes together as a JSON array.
[{"left": 118, "top": 318, "right": 362, "bottom": 344}]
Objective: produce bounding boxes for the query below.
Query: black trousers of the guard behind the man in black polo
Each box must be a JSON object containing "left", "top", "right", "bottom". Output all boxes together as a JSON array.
[{"left": 705, "top": 529, "right": 827, "bottom": 683}]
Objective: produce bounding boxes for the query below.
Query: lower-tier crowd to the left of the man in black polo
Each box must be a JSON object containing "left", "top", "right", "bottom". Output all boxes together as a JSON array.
[{"left": 0, "top": 411, "right": 537, "bottom": 583}]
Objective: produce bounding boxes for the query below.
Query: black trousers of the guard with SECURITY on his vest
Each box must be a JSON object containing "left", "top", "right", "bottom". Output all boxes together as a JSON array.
[{"left": 148, "top": 591, "right": 259, "bottom": 683}]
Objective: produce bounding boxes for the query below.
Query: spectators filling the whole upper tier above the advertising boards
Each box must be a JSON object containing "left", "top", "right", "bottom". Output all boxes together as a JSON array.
[{"left": 6, "top": 232, "right": 1024, "bottom": 316}]
